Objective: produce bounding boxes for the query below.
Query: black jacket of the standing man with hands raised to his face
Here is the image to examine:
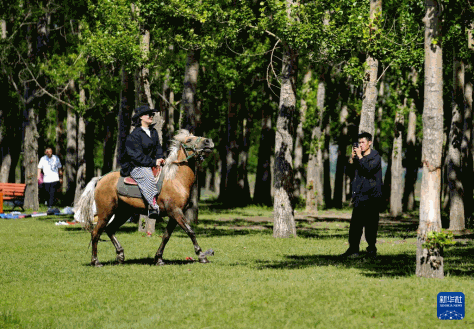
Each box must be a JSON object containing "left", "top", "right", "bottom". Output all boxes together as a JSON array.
[{"left": 352, "top": 150, "right": 382, "bottom": 206}]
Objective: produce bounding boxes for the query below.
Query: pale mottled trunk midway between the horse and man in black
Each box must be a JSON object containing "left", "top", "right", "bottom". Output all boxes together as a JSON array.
[{"left": 273, "top": 43, "right": 297, "bottom": 238}]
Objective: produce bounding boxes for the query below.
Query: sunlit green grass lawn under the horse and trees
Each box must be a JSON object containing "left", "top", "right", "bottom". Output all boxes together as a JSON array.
[{"left": 0, "top": 205, "right": 474, "bottom": 329}]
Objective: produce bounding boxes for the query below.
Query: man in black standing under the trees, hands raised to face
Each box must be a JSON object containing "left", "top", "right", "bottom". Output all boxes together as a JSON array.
[{"left": 341, "top": 132, "right": 382, "bottom": 259}]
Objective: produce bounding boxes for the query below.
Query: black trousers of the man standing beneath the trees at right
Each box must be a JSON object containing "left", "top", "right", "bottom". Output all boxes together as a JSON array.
[{"left": 349, "top": 198, "right": 380, "bottom": 252}]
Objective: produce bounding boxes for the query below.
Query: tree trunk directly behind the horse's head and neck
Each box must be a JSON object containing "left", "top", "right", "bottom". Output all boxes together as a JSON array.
[{"left": 181, "top": 50, "right": 201, "bottom": 224}]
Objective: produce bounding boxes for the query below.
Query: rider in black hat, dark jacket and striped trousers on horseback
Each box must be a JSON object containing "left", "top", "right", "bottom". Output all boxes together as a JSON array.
[{"left": 120, "top": 105, "right": 165, "bottom": 219}]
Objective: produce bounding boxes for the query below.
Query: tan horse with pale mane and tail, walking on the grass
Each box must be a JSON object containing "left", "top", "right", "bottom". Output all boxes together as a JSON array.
[{"left": 76, "top": 130, "right": 214, "bottom": 266}]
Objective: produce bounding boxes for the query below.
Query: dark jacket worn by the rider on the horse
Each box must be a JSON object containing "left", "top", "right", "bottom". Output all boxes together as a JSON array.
[{"left": 120, "top": 126, "right": 164, "bottom": 177}]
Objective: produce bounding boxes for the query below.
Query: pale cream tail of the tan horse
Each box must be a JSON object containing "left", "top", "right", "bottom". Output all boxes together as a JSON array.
[{"left": 74, "top": 177, "right": 101, "bottom": 232}]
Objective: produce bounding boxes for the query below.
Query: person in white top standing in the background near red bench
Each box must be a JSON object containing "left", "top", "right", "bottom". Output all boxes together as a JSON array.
[{"left": 38, "top": 147, "right": 63, "bottom": 209}]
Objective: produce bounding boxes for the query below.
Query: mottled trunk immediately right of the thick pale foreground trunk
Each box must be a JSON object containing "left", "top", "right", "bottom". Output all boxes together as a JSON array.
[{"left": 448, "top": 60, "right": 466, "bottom": 233}]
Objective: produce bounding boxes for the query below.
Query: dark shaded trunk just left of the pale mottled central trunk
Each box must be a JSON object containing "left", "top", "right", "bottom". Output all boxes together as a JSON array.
[{"left": 253, "top": 99, "right": 275, "bottom": 207}]
